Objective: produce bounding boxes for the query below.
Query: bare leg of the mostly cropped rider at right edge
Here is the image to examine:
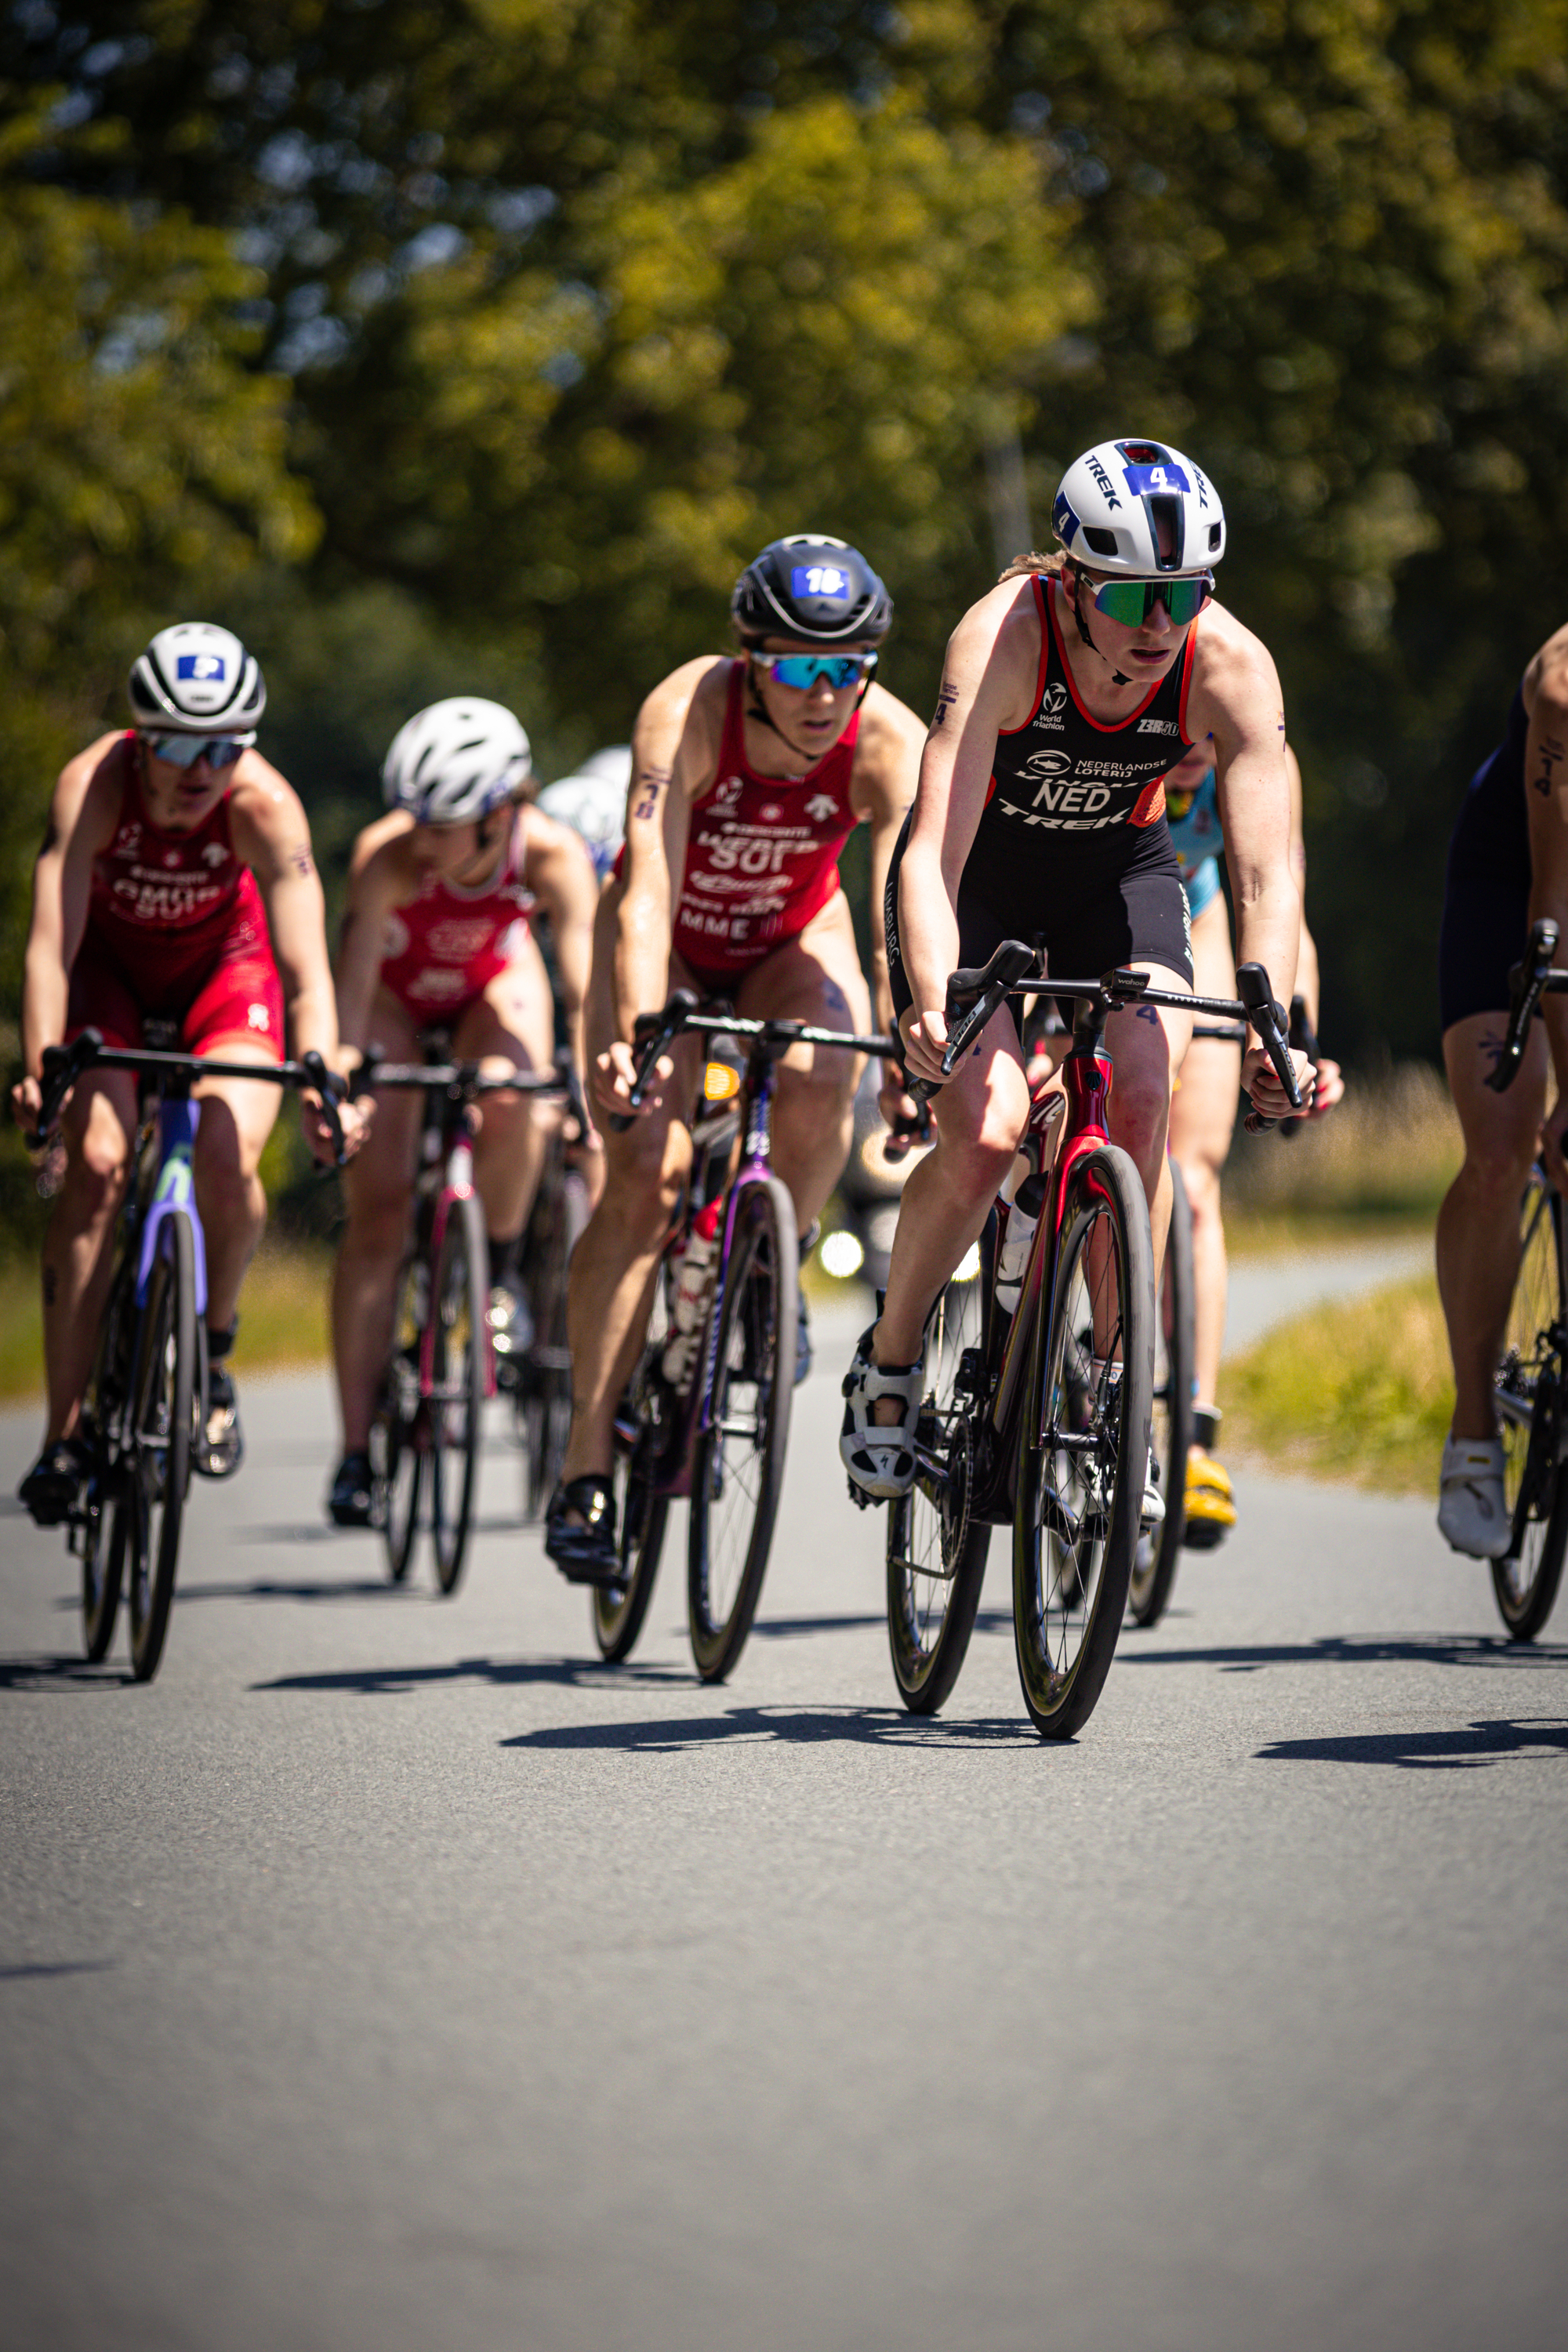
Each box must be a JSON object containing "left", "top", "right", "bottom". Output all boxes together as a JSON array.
[{"left": 1436, "top": 1014, "right": 1547, "bottom": 1439}]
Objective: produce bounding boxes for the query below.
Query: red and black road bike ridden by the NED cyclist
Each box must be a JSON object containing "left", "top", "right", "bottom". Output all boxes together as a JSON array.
[{"left": 884, "top": 938, "right": 1300, "bottom": 1738}]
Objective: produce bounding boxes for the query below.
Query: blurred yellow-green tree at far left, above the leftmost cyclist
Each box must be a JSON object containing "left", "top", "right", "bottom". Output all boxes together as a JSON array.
[{"left": 0, "top": 108, "right": 315, "bottom": 1004}]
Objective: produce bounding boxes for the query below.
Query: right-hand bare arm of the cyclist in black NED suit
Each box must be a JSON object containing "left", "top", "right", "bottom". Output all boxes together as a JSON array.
[{"left": 1187, "top": 604, "right": 1305, "bottom": 1117}]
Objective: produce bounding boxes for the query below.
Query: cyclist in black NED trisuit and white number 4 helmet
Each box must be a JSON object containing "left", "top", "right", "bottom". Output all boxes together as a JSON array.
[{"left": 839, "top": 440, "right": 1312, "bottom": 1524}]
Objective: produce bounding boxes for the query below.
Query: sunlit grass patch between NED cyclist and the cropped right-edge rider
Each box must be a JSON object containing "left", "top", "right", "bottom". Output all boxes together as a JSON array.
[{"left": 1225, "top": 1275, "right": 1453, "bottom": 1494}]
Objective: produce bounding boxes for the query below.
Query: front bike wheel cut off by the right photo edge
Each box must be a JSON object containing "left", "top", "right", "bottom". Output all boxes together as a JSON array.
[{"left": 1490, "top": 1169, "right": 1568, "bottom": 1642}]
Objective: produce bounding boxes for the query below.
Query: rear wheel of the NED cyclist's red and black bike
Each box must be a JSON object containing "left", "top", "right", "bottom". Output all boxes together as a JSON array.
[{"left": 886, "top": 1279, "right": 992, "bottom": 1715}]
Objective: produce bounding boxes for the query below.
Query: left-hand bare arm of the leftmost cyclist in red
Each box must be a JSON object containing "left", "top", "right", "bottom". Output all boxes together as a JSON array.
[{"left": 12, "top": 734, "right": 125, "bottom": 1127}]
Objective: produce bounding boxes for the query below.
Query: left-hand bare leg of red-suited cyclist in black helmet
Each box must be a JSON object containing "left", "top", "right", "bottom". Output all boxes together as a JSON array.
[{"left": 562, "top": 884, "right": 701, "bottom": 1519}]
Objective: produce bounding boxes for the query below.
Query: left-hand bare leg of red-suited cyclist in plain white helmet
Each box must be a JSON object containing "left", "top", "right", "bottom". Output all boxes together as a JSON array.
[{"left": 332, "top": 990, "right": 423, "bottom": 1454}]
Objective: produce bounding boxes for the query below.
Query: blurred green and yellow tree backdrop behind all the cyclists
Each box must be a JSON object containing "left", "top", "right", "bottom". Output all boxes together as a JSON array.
[{"left": 0, "top": 0, "right": 1568, "bottom": 1082}]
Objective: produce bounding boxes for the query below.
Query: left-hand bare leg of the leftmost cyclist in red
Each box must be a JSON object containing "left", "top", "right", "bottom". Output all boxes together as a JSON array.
[{"left": 42, "top": 1070, "right": 136, "bottom": 1444}]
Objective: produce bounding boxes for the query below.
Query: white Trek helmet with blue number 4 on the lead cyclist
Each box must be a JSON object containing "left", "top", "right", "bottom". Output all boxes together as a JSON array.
[{"left": 1051, "top": 440, "right": 1225, "bottom": 579}]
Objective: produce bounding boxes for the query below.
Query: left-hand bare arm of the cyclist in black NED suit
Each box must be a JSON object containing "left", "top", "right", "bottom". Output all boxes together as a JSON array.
[{"left": 898, "top": 581, "right": 1039, "bottom": 1080}]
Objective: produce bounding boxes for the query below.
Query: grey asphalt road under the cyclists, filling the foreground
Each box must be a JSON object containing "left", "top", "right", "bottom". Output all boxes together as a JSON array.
[{"left": 0, "top": 1298, "right": 1568, "bottom": 2352}]
